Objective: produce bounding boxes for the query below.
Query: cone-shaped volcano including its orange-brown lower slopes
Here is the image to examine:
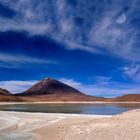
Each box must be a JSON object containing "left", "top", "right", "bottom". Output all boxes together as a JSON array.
[{"left": 18, "top": 78, "right": 104, "bottom": 101}]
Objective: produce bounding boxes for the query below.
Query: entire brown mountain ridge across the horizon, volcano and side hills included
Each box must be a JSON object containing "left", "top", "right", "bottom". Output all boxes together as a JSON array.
[{"left": 0, "top": 78, "right": 140, "bottom": 102}]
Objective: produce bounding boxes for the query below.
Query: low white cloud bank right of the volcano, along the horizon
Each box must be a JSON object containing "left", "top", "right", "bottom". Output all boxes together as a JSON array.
[{"left": 60, "top": 77, "right": 140, "bottom": 97}]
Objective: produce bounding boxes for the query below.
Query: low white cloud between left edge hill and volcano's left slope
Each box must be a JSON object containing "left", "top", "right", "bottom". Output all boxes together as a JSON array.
[{"left": 0, "top": 80, "right": 37, "bottom": 94}]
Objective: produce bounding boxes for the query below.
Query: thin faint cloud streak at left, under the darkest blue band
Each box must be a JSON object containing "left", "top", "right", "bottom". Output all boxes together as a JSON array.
[{"left": 0, "top": 53, "right": 57, "bottom": 68}]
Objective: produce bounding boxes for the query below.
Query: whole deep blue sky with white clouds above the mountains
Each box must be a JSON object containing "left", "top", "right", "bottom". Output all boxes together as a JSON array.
[{"left": 0, "top": 0, "right": 140, "bottom": 97}]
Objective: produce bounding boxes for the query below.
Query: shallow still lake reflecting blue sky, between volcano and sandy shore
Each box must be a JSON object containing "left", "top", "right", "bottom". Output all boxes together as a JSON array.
[{"left": 0, "top": 103, "right": 140, "bottom": 115}]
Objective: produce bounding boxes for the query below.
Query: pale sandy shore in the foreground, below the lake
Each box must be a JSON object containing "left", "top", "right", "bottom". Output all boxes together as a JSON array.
[{"left": 0, "top": 110, "right": 140, "bottom": 140}]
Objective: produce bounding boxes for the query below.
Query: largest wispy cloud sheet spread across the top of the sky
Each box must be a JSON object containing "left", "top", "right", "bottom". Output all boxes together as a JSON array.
[{"left": 0, "top": 0, "right": 140, "bottom": 61}]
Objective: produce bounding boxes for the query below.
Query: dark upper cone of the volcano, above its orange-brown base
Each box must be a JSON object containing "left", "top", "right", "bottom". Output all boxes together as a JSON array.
[{"left": 22, "top": 78, "right": 83, "bottom": 95}]
